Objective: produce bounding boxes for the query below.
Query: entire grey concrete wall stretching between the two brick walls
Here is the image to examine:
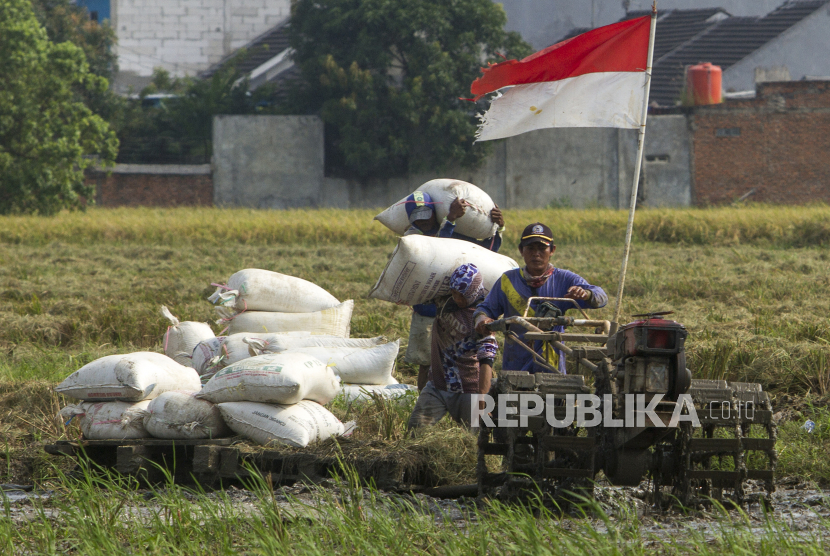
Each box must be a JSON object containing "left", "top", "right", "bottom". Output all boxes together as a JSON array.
[{"left": 213, "top": 116, "right": 691, "bottom": 208}]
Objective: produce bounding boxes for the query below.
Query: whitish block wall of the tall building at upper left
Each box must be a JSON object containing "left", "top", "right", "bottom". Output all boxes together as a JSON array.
[{"left": 111, "top": 0, "right": 291, "bottom": 89}]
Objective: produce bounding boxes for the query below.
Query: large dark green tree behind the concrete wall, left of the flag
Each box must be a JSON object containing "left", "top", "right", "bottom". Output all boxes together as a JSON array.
[{"left": 286, "top": 0, "right": 531, "bottom": 177}]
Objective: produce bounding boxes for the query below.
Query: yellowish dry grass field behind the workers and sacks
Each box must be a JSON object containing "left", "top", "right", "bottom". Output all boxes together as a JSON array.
[{"left": 0, "top": 206, "right": 830, "bottom": 486}]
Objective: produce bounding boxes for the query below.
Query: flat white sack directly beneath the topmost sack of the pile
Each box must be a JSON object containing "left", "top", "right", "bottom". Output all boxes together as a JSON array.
[{"left": 220, "top": 299, "right": 354, "bottom": 338}]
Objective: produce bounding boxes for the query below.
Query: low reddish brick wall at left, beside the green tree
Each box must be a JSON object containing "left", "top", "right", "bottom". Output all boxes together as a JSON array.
[{"left": 87, "top": 164, "right": 213, "bottom": 207}]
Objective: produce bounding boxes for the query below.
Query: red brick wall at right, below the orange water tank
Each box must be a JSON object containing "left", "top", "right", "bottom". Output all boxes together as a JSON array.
[{"left": 690, "top": 81, "right": 830, "bottom": 205}]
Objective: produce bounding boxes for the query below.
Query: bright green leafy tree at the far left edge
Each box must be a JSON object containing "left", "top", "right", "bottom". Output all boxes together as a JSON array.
[{"left": 0, "top": 0, "right": 118, "bottom": 214}]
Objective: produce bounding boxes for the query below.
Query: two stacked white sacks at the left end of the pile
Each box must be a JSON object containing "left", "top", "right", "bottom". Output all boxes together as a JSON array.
[{"left": 55, "top": 352, "right": 201, "bottom": 440}]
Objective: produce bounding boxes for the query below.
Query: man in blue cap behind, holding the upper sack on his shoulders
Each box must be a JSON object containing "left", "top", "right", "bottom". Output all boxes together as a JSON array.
[{"left": 404, "top": 191, "right": 504, "bottom": 390}]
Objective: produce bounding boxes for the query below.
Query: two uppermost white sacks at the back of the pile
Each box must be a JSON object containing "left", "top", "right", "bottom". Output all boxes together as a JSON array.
[{"left": 209, "top": 268, "right": 354, "bottom": 338}]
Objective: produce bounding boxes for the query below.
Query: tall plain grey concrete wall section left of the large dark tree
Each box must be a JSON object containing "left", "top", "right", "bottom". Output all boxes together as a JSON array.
[{"left": 213, "top": 116, "right": 324, "bottom": 209}]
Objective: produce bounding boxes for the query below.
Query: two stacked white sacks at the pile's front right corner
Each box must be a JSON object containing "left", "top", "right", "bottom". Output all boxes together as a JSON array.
[{"left": 198, "top": 353, "right": 345, "bottom": 447}]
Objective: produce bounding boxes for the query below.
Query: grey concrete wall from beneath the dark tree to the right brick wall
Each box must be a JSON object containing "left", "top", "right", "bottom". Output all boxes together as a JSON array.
[{"left": 322, "top": 115, "right": 692, "bottom": 208}]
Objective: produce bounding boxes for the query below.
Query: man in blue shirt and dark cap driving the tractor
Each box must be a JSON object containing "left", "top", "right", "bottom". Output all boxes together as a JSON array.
[{"left": 475, "top": 222, "right": 608, "bottom": 373}]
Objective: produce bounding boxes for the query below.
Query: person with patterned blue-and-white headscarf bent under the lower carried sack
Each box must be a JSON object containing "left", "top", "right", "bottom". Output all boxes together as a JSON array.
[{"left": 408, "top": 264, "right": 498, "bottom": 429}]
